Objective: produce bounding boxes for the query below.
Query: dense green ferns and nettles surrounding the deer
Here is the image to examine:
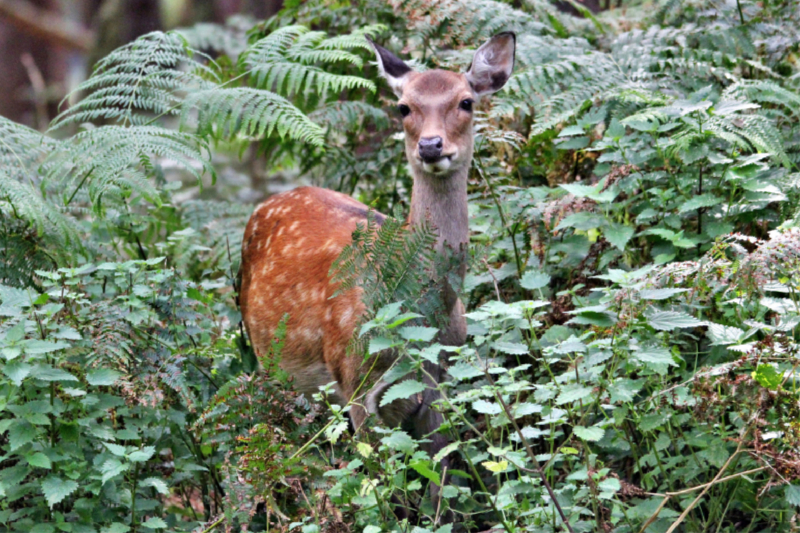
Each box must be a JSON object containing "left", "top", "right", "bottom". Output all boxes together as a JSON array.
[{"left": 0, "top": 0, "right": 800, "bottom": 533}]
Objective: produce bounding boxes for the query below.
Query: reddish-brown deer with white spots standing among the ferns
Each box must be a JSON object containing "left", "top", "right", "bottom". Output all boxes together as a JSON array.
[{"left": 239, "top": 32, "right": 516, "bottom": 455}]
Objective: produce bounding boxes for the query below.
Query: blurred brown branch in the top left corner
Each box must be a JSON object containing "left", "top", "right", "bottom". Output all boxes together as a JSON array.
[{"left": 0, "top": 0, "right": 94, "bottom": 52}]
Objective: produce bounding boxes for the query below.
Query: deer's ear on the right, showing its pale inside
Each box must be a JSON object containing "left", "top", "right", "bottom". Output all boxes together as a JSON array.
[{"left": 467, "top": 31, "right": 517, "bottom": 96}]
